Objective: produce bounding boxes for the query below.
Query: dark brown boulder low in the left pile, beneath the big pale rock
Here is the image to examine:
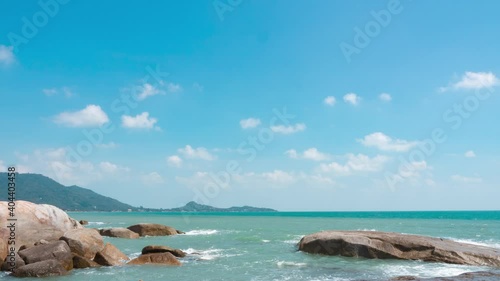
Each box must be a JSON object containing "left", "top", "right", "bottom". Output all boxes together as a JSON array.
[{"left": 18, "top": 241, "right": 73, "bottom": 270}]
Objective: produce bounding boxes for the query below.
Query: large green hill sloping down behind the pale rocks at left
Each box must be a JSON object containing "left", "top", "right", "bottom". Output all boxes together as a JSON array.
[{"left": 0, "top": 173, "right": 137, "bottom": 211}]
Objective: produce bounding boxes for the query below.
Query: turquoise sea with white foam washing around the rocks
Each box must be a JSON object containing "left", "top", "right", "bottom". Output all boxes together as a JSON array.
[{"left": 0, "top": 211, "right": 500, "bottom": 281}]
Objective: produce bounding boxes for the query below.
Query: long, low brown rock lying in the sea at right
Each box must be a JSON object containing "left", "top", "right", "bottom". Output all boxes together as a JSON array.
[{"left": 299, "top": 231, "right": 500, "bottom": 267}]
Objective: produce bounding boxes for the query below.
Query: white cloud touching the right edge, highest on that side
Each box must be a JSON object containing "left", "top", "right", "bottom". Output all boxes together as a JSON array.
[{"left": 439, "top": 71, "right": 500, "bottom": 92}]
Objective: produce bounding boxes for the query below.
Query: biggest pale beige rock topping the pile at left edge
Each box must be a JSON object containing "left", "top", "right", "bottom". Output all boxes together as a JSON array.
[{"left": 0, "top": 200, "right": 82, "bottom": 248}]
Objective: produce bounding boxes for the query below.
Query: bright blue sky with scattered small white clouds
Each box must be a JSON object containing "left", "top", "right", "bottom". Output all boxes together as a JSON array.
[{"left": 0, "top": 0, "right": 500, "bottom": 210}]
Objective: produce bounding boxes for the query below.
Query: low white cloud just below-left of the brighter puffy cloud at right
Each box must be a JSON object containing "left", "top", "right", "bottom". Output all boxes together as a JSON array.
[{"left": 320, "top": 154, "right": 389, "bottom": 175}]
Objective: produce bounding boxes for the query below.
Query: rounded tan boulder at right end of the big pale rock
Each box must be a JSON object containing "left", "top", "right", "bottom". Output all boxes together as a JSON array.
[{"left": 60, "top": 228, "right": 104, "bottom": 259}]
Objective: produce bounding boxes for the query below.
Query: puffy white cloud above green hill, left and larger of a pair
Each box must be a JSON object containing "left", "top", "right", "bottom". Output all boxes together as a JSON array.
[{"left": 54, "top": 104, "right": 109, "bottom": 128}]
